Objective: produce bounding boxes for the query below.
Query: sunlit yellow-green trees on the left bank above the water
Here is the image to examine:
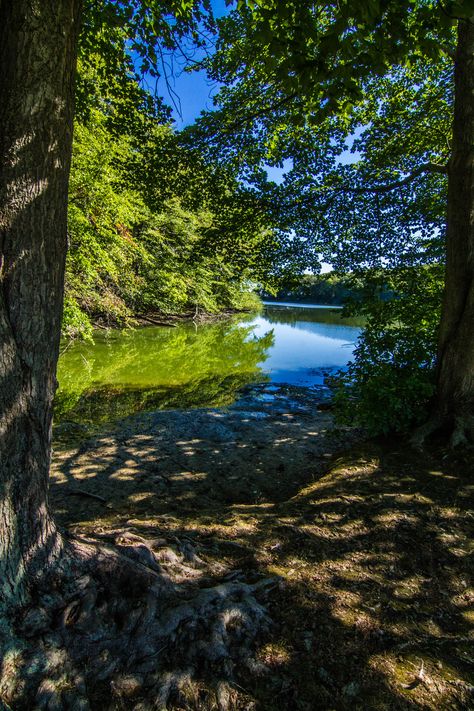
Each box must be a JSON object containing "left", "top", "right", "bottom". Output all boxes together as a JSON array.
[{"left": 63, "top": 57, "right": 278, "bottom": 337}]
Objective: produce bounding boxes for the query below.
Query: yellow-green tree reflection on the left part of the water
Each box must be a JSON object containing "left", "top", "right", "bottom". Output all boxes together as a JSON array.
[{"left": 55, "top": 317, "right": 274, "bottom": 432}]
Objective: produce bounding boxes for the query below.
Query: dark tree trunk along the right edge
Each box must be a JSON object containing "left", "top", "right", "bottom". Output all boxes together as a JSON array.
[{"left": 437, "top": 20, "right": 474, "bottom": 430}]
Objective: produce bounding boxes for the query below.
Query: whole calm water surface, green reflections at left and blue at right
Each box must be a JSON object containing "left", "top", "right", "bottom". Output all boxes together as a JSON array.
[{"left": 56, "top": 304, "right": 360, "bottom": 432}]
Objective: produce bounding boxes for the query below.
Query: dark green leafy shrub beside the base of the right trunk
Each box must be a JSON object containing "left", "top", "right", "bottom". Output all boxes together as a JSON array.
[{"left": 333, "top": 266, "right": 443, "bottom": 435}]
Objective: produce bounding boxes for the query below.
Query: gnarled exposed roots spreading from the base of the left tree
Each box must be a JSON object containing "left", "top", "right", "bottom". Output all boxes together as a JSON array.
[{"left": 0, "top": 532, "right": 273, "bottom": 711}]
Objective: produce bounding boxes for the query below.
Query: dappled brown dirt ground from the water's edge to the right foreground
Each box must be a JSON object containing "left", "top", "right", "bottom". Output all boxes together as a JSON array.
[{"left": 51, "top": 385, "right": 474, "bottom": 711}]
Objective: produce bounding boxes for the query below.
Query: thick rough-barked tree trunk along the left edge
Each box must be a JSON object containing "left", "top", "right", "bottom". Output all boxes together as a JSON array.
[{"left": 0, "top": 0, "right": 79, "bottom": 606}]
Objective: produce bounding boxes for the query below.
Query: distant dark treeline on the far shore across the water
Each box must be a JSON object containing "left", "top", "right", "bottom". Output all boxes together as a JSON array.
[{"left": 261, "top": 273, "right": 392, "bottom": 306}]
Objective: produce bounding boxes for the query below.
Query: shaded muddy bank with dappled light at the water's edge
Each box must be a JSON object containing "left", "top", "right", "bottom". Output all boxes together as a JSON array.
[{"left": 51, "top": 384, "right": 358, "bottom": 523}]
